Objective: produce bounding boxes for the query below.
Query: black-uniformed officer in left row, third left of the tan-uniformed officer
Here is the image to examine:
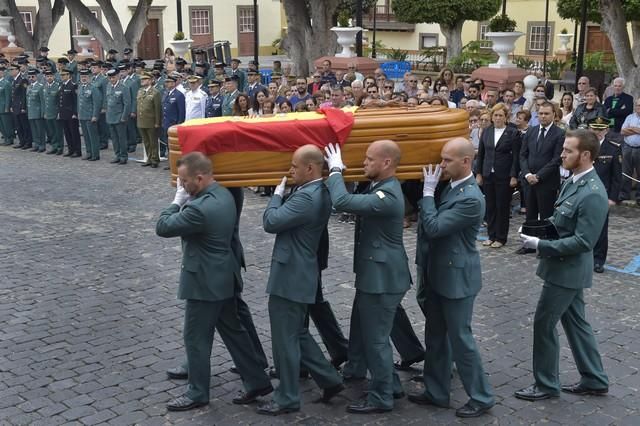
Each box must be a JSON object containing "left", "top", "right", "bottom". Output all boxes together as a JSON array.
[{"left": 58, "top": 68, "right": 82, "bottom": 158}]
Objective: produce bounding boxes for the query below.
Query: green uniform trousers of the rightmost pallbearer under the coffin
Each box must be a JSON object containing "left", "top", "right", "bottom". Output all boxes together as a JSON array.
[{"left": 424, "top": 289, "right": 495, "bottom": 408}]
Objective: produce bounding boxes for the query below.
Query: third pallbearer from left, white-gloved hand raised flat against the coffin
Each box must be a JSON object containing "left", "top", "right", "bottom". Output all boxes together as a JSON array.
[{"left": 325, "top": 140, "right": 411, "bottom": 414}]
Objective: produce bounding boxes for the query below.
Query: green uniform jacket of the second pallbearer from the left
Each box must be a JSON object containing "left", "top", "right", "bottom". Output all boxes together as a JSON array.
[{"left": 262, "top": 180, "right": 331, "bottom": 303}]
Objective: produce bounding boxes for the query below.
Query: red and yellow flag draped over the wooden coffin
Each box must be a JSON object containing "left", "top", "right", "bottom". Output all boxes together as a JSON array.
[{"left": 178, "top": 107, "right": 356, "bottom": 155}]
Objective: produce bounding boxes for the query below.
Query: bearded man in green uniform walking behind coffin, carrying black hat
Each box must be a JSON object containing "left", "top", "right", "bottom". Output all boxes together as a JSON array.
[{"left": 515, "top": 130, "right": 609, "bottom": 401}]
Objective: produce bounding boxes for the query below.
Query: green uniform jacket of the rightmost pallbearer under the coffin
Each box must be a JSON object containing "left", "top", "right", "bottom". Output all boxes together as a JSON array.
[{"left": 420, "top": 176, "right": 485, "bottom": 299}]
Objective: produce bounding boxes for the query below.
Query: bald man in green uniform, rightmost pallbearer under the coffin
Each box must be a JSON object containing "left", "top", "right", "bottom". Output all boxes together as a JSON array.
[{"left": 409, "top": 138, "right": 495, "bottom": 417}]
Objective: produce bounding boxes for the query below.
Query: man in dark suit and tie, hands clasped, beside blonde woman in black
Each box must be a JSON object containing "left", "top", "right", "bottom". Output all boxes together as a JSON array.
[{"left": 516, "top": 102, "right": 564, "bottom": 254}]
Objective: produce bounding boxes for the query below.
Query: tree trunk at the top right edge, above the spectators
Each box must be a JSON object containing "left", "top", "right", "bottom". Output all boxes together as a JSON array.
[{"left": 600, "top": 0, "right": 640, "bottom": 97}]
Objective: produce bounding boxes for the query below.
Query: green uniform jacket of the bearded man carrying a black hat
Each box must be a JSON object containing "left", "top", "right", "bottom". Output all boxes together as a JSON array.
[{"left": 537, "top": 170, "right": 609, "bottom": 289}]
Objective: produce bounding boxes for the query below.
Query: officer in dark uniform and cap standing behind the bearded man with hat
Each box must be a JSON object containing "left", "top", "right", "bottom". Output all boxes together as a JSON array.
[{"left": 589, "top": 116, "right": 622, "bottom": 274}]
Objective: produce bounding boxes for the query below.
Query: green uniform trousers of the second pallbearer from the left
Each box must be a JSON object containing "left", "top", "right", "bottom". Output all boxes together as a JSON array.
[{"left": 269, "top": 295, "right": 342, "bottom": 408}]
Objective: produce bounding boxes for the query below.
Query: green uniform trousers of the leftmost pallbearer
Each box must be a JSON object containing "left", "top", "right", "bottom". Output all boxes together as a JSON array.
[{"left": 184, "top": 297, "right": 271, "bottom": 402}]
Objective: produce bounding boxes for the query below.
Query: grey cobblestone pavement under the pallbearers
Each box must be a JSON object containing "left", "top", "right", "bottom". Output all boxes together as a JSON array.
[{"left": 0, "top": 147, "right": 640, "bottom": 425}]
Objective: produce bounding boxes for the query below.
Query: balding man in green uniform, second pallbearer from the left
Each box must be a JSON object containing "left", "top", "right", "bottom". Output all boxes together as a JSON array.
[{"left": 258, "top": 145, "right": 344, "bottom": 415}]
